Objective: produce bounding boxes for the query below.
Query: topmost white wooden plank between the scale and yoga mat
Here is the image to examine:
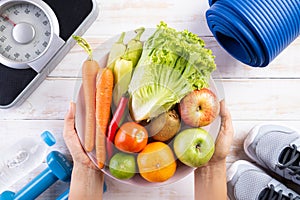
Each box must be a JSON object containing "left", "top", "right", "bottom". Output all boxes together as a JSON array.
[{"left": 86, "top": 0, "right": 211, "bottom": 36}]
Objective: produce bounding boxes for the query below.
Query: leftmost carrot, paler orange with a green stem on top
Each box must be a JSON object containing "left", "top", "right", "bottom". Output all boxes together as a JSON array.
[{"left": 73, "top": 36, "right": 100, "bottom": 152}]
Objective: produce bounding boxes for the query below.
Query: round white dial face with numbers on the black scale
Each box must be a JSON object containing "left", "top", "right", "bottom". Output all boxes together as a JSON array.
[{"left": 0, "top": 2, "right": 52, "bottom": 63}]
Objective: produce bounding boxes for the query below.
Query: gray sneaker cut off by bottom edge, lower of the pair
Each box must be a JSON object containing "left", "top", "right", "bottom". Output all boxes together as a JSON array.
[{"left": 227, "top": 160, "right": 300, "bottom": 200}]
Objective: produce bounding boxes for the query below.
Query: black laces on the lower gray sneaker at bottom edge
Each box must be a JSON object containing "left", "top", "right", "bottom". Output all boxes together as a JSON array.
[{"left": 258, "top": 184, "right": 300, "bottom": 200}]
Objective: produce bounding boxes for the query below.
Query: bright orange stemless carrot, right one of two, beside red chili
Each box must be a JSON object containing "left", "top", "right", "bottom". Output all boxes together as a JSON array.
[{"left": 96, "top": 68, "right": 114, "bottom": 169}]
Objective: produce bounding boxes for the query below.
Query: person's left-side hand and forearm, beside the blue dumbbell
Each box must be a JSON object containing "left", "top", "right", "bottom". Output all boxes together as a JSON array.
[{"left": 63, "top": 103, "right": 104, "bottom": 200}]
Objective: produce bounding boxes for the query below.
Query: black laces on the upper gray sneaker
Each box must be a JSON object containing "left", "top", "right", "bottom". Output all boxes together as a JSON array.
[{"left": 279, "top": 144, "right": 300, "bottom": 180}]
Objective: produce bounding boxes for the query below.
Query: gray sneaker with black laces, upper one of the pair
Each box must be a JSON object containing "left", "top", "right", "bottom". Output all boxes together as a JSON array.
[{"left": 244, "top": 125, "right": 300, "bottom": 185}]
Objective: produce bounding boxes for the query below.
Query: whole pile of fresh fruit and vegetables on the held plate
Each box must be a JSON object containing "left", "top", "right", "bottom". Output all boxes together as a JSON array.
[{"left": 74, "top": 22, "right": 219, "bottom": 182}]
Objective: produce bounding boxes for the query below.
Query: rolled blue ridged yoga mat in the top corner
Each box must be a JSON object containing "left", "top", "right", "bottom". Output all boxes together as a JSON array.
[{"left": 206, "top": 0, "right": 300, "bottom": 67}]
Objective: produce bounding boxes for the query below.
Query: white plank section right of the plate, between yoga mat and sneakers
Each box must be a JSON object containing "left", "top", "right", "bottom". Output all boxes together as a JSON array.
[{"left": 216, "top": 79, "right": 300, "bottom": 120}]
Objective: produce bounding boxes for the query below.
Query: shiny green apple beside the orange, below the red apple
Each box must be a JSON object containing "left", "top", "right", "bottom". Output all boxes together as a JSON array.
[{"left": 173, "top": 128, "right": 215, "bottom": 167}]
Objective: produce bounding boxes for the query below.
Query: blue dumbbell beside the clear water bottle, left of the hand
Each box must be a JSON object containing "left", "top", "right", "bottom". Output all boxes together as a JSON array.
[{"left": 0, "top": 151, "right": 73, "bottom": 200}]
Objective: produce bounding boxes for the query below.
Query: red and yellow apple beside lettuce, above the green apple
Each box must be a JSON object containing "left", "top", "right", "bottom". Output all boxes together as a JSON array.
[{"left": 179, "top": 88, "right": 220, "bottom": 127}]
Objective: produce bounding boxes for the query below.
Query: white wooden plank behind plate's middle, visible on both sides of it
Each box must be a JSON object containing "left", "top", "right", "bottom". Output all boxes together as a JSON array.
[{"left": 0, "top": 78, "right": 300, "bottom": 120}]
